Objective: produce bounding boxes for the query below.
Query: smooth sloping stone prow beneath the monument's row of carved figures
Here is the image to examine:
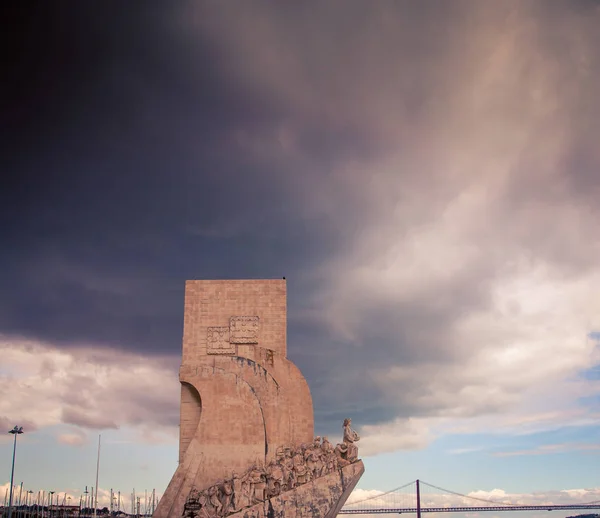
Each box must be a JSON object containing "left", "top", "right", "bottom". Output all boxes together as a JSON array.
[{"left": 228, "top": 460, "right": 365, "bottom": 518}]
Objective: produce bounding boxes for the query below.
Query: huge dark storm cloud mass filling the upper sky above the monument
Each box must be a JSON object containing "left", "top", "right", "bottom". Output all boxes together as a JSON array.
[{"left": 0, "top": 0, "right": 600, "bottom": 446}]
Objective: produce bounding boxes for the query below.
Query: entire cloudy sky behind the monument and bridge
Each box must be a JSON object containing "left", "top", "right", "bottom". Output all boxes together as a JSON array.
[{"left": 0, "top": 0, "right": 600, "bottom": 516}]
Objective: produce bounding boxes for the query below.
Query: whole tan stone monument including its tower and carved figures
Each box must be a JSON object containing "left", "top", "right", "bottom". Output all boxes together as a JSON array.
[{"left": 153, "top": 279, "right": 364, "bottom": 518}]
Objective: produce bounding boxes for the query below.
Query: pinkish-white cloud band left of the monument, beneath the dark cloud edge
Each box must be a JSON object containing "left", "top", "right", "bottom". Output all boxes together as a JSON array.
[{"left": 0, "top": 337, "right": 179, "bottom": 445}]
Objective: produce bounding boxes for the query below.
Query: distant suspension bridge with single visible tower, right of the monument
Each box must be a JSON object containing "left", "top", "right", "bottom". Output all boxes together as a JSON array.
[{"left": 339, "top": 480, "right": 600, "bottom": 518}]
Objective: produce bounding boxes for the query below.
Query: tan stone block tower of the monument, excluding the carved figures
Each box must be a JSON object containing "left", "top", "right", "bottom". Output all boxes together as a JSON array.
[{"left": 155, "top": 279, "right": 314, "bottom": 518}]
